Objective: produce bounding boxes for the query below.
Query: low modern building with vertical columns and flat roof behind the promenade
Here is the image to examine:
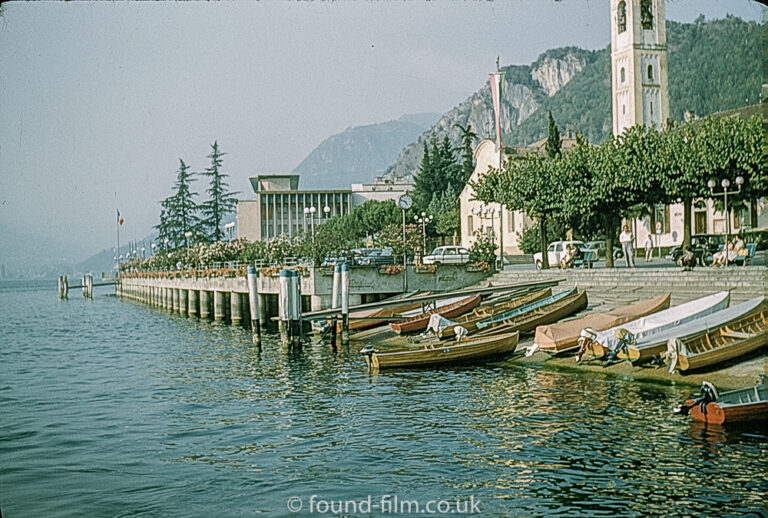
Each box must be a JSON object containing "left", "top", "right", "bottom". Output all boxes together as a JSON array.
[{"left": 237, "top": 174, "right": 413, "bottom": 241}]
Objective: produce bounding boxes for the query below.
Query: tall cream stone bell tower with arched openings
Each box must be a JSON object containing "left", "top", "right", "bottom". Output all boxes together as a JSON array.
[{"left": 611, "top": 0, "right": 669, "bottom": 135}]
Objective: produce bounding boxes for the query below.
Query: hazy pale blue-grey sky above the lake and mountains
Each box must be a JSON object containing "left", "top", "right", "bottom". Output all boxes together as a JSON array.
[{"left": 0, "top": 0, "right": 761, "bottom": 258}]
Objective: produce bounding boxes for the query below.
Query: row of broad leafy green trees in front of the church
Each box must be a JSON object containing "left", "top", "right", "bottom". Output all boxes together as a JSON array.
[{"left": 473, "top": 115, "right": 768, "bottom": 268}]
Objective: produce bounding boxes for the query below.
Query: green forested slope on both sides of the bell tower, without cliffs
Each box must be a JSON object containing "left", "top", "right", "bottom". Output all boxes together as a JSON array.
[{"left": 505, "top": 17, "right": 762, "bottom": 146}]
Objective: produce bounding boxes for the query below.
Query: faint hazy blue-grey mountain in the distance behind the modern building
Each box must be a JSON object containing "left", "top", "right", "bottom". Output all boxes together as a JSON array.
[{"left": 293, "top": 113, "right": 440, "bottom": 189}]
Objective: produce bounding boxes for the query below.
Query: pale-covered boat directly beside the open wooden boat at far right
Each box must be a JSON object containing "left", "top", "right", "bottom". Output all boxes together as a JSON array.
[{"left": 619, "top": 296, "right": 768, "bottom": 366}]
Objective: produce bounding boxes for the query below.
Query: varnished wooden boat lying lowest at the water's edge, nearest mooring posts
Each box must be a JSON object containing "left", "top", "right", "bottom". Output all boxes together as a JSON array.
[{"left": 360, "top": 332, "right": 519, "bottom": 370}]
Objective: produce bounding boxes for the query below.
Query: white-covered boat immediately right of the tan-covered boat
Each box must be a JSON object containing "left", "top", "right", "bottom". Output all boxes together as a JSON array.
[{"left": 585, "top": 291, "right": 731, "bottom": 357}]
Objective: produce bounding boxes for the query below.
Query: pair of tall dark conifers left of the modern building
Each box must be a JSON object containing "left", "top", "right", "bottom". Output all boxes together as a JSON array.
[{"left": 155, "top": 141, "right": 238, "bottom": 247}]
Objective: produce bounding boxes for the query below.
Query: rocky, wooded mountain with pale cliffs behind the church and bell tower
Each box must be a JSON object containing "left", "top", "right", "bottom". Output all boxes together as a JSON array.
[{"left": 386, "top": 16, "right": 762, "bottom": 183}]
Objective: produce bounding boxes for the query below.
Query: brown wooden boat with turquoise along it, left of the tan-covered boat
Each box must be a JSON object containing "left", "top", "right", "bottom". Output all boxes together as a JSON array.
[{"left": 477, "top": 288, "right": 587, "bottom": 336}]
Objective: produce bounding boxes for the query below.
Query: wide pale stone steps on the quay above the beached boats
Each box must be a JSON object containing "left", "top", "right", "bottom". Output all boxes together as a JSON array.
[{"left": 483, "top": 266, "right": 768, "bottom": 306}]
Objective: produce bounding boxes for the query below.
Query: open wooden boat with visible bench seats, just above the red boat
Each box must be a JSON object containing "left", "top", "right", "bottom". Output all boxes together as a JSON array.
[{"left": 677, "top": 308, "right": 768, "bottom": 372}]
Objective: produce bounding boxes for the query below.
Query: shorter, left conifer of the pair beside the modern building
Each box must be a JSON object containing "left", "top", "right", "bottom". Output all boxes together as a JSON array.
[{"left": 155, "top": 159, "right": 200, "bottom": 247}]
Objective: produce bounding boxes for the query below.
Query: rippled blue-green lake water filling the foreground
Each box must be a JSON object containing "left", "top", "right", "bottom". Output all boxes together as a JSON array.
[{"left": 0, "top": 282, "right": 768, "bottom": 518}]
